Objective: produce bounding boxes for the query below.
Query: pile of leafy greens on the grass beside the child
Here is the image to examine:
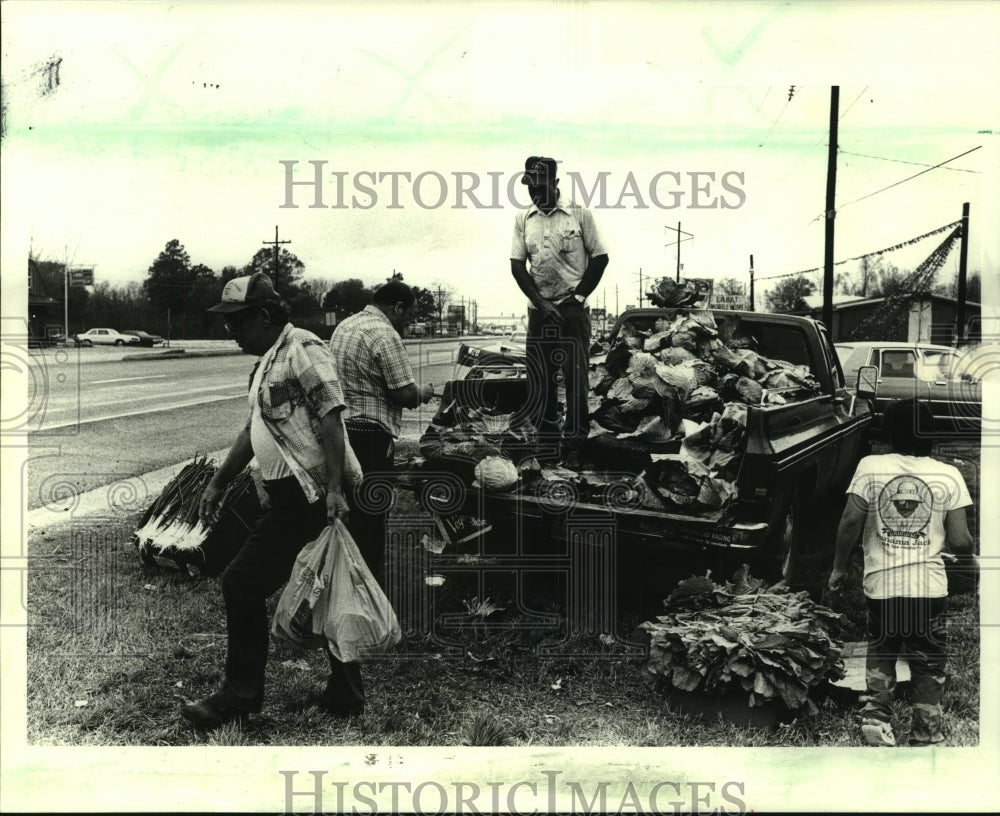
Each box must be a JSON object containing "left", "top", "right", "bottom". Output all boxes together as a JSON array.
[{"left": 642, "top": 566, "right": 844, "bottom": 712}]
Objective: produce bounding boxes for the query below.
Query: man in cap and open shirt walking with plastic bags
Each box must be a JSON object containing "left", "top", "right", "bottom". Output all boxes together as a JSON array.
[{"left": 181, "top": 272, "right": 365, "bottom": 729}]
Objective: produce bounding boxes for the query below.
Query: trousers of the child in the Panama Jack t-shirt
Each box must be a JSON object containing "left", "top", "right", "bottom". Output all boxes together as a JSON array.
[{"left": 861, "top": 598, "right": 947, "bottom": 743}]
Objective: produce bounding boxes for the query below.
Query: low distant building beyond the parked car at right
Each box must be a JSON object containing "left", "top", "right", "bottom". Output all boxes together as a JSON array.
[{"left": 790, "top": 294, "right": 982, "bottom": 345}]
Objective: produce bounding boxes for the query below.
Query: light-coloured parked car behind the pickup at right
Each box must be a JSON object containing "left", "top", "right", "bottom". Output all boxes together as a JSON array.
[{"left": 836, "top": 340, "right": 983, "bottom": 436}]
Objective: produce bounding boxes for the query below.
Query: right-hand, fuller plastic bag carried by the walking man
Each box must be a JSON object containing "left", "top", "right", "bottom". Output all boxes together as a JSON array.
[{"left": 323, "top": 520, "right": 402, "bottom": 663}]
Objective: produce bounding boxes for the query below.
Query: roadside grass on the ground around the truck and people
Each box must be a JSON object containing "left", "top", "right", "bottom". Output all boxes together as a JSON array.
[{"left": 26, "top": 444, "right": 980, "bottom": 747}]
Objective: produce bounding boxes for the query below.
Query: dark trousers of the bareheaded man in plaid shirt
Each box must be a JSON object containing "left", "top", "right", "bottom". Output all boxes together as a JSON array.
[{"left": 345, "top": 419, "right": 396, "bottom": 589}]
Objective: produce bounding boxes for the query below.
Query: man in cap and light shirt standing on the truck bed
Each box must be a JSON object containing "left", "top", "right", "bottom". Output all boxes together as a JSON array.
[{"left": 510, "top": 156, "right": 608, "bottom": 460}]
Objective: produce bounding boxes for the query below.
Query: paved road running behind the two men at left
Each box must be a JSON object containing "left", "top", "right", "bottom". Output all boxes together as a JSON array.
[{"left": 22, "top": 342, "right": 468, "bottom": 508}]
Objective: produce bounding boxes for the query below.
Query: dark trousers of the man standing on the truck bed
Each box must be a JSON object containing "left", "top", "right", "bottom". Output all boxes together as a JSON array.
[{"left": 525, "top": 298, "right": 590, "bottom": 446}]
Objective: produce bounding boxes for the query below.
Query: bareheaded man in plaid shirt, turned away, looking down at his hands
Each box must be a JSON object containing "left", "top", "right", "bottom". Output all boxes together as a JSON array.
[{"left": 330, "top": 279, "right": 434, "bottom": 582}]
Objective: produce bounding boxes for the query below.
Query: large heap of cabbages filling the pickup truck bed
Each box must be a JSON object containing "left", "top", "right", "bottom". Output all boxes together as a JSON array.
[{"left": 589, "top": 309, "right": 819, "bottom": 514}]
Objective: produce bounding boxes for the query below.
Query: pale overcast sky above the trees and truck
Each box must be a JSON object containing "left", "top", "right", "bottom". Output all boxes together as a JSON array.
[{"left": 3, "top": 2, "right": 1000, "bottom": 314}]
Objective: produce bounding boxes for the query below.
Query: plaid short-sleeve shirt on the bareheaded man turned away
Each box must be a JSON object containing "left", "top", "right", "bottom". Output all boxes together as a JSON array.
[{"left": 330, "top": 306, "right": 415, "bottom": 437}]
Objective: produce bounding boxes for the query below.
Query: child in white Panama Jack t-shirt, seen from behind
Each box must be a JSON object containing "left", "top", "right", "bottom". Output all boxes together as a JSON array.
[{"left": 829, "top": 399, "right": 973, "bottom": 745}]
